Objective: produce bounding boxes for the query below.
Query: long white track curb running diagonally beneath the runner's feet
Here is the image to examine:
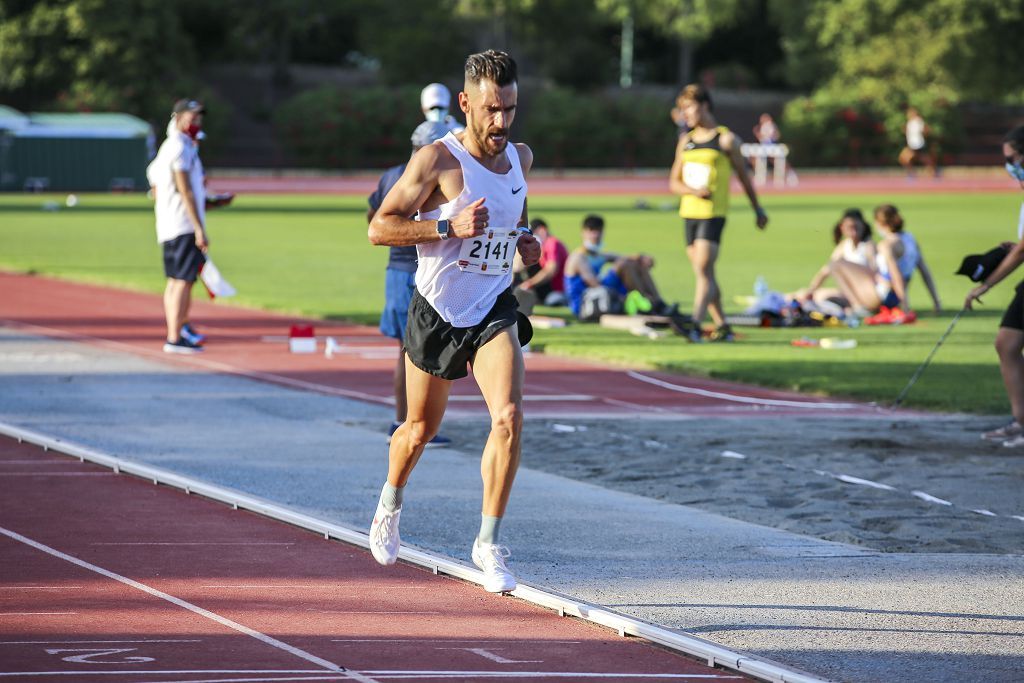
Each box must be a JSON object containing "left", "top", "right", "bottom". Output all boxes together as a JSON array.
[{"left": 0, "top": 422, "right": 827, "bottom": 683}]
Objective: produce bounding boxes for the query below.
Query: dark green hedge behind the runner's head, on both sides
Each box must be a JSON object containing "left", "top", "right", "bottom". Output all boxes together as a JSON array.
[{"left": 274, "top": 86, "right": 676, "bottom": 169}]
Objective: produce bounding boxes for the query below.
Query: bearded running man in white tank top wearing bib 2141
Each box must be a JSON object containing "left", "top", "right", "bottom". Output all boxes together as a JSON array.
[{"left": 370, "top": 50, "right": 541, "bottom": 593}]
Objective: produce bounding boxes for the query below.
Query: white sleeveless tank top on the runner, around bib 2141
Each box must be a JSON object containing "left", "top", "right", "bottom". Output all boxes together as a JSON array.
[{"left": 416, "top": 133, "right": 526, "bottom": 328}]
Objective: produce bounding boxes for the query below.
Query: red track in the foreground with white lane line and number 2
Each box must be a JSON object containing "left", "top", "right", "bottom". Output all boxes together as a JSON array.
[{"left": 0, "top": 437, "right": 751, "bottom": 683}]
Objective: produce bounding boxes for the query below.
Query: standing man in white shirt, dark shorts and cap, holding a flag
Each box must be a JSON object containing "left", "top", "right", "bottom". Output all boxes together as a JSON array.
[{"left": 145, "top": 99, "right": 219, "bottom": 353}]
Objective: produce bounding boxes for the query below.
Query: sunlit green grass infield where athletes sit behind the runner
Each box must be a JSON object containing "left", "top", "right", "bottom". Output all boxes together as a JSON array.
[{"left": 0, "top": 193, "right": 1021, "bottom": 414}]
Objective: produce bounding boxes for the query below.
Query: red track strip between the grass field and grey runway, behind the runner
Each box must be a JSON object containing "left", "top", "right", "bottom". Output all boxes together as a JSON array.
[{"left": 0, "top": 273, "right": 879, "bottom": 418}]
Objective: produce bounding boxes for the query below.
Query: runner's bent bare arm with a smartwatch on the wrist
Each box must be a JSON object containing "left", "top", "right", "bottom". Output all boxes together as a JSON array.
[{"left": 368, "top": 144, "right": 487, "bottom": 247}]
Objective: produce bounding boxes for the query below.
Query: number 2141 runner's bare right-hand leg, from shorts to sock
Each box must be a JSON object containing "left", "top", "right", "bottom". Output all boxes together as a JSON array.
[{"left": 473, "top": 325, "right": 525, "bottom": 517}]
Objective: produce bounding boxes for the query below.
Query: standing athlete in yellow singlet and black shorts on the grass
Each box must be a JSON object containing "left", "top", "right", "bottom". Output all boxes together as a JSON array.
[{"left": 669, "top": 85, "right": 768, "bottom": 341}]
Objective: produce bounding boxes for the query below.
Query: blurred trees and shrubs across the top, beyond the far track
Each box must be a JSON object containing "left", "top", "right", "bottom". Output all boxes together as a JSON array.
[{"left": 0, "top": 0, "right": 1024, "bottom": 169}]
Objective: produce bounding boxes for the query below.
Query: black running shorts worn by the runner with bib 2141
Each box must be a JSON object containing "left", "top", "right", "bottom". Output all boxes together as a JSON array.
[{"left": 406, "top": 289, "right": 528, "bottom": 380}]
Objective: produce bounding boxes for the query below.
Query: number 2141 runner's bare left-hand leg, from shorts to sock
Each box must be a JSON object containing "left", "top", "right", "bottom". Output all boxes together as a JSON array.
[{"left": 387, "top": 355, "right": 452, "bottom": 487}]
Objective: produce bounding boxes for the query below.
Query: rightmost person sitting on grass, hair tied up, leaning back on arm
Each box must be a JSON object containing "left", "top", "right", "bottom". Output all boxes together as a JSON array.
[{"left": 831, "top": 204, "right": 942, "bottom": 325}]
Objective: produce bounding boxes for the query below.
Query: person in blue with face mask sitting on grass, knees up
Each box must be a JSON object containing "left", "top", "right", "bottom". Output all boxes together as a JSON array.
[{"left": 565, "top": 214, "right": 672, "bottom": 319}]
